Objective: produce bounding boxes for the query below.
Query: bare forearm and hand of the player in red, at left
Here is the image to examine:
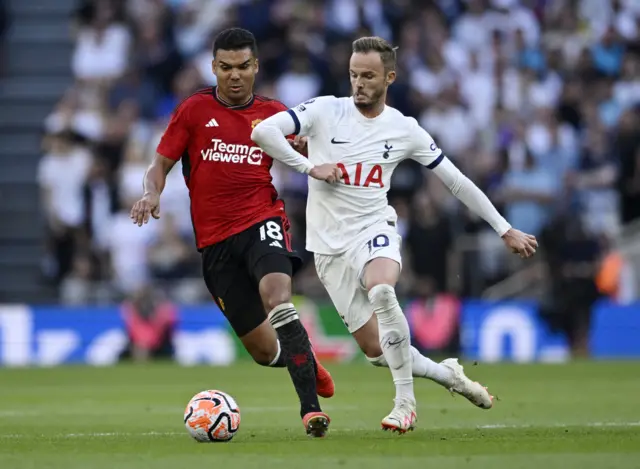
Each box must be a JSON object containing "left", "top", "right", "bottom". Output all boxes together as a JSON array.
[{"left": 130, "top": 153, "right": 176, "bottom": 226}]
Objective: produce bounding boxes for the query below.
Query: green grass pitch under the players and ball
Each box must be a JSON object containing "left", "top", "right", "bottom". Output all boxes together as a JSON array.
[{"left": 0, "top": 362, "right": 640, "bottom": 469}]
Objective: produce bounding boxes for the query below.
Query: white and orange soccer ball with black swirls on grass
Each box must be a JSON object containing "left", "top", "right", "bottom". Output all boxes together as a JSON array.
[{"left": 184, "top": 390, "right": 240, "bottom": 442}]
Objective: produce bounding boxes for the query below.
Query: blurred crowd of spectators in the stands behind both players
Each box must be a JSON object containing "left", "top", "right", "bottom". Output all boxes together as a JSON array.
[{"left": 39, "top": 0, "right": 640, "bottom": 303}]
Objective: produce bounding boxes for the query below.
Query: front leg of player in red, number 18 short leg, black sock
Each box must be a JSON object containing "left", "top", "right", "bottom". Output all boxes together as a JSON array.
[{"left": 246, "top": 218, "right": 333, "bottom": 436}]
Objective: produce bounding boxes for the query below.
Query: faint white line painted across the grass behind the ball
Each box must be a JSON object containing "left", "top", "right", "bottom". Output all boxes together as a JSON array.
[{"left": 0, "top": 422, "right": 640, "bottom": 440}]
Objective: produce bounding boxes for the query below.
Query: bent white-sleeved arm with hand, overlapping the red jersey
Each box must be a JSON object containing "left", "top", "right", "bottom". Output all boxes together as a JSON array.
[{"left": 251, "top": 111, "right": 342, "bottom": 183}]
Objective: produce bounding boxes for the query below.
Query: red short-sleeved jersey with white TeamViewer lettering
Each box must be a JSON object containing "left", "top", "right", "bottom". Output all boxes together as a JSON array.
[{"left": 157, "top": 87, "right": 287, "bottom": 249}]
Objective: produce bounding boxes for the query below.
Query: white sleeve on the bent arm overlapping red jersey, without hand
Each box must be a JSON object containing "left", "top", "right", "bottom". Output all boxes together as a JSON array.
[{"left": 251, "top": 112, "right": 313, "bottom": 174}]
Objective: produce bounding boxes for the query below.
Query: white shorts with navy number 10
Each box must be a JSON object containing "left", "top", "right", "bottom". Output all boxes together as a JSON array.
[{"left": 314, "top": 223, "right": 402, "bottom": 333}]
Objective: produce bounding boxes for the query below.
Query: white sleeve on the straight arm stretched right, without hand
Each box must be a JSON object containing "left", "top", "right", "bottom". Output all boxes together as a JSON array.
[{"left": 433, "top": 158, "right": 511, "bottom": 236}]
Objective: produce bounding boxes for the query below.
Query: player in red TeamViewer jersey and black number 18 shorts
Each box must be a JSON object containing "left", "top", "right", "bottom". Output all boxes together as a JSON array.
[{"left": 131, "top": 28, "right": 334, "bottom": 436}]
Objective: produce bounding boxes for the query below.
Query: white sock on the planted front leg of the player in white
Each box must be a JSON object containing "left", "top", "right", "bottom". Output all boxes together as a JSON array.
[{"left": 369, "top": 285, "right": 415, "bottom": 401}]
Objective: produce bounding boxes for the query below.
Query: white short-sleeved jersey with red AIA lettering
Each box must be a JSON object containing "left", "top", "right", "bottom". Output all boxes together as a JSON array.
[{"left": 288, "top": 96, "right": 444, "bottom": 255}]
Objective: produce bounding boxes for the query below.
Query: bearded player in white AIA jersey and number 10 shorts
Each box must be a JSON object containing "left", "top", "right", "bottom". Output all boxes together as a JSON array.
[{"left": 251, "top": 37, "right": 537, "bottom": 433}]
